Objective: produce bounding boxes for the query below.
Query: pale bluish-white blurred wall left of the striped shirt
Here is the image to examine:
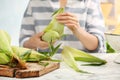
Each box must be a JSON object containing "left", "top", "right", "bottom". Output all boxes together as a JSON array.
[{"left": 0, "top": 0, "right": 29, "bottom": 45}]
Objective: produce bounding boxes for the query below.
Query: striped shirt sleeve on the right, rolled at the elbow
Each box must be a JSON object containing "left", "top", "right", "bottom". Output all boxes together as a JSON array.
[{"left": 87, "top": 0, "right": 106, "bottom": 53}]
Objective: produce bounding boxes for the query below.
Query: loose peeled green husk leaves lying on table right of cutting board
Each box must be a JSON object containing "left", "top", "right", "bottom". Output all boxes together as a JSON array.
[{"left": 62, "top": 46, "right": 106, "bottom": 72}]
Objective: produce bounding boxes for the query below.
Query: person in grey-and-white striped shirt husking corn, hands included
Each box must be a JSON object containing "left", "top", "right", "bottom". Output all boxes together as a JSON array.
[{"left": 20, "top": 0, "right": 106, "bottom": 53}]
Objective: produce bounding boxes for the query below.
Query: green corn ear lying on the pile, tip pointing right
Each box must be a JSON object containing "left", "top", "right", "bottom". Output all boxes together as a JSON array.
[{"left": 12, "top": 46, "right": 47, "bottom": 61}]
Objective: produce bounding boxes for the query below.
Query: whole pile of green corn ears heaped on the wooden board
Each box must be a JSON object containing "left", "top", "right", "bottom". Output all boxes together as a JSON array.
[{"left": 0, "top": 30, "right": 46, "bottom": 68}]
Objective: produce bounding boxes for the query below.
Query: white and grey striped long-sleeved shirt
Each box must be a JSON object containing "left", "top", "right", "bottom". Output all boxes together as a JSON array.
[{"left": 19, "top": 0, "right": 106, "bottom": 53}]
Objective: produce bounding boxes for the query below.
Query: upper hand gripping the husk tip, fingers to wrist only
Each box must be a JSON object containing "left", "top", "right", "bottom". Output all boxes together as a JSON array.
[{"left": 56, "top": 12, "right": 80, "bottom": 32}]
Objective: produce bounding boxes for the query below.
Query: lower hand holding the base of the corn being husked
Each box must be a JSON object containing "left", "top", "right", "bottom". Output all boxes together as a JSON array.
[{"left": 23, "top": 32, "right": 49, "bottom": 50}]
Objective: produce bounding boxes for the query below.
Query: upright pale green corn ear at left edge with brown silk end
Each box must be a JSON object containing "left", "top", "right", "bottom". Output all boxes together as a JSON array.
[{"left": 0, "top": 30, "right": 26, "bottom": 68}]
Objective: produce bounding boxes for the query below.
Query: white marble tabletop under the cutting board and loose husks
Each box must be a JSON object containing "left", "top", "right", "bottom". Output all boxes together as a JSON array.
[{"left": 0, "top": 53, "right": 120, "bottom": 80}]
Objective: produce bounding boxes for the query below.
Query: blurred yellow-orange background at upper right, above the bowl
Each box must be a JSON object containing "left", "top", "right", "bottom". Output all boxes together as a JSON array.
[{"left": 101, "top": 0, "right": 120, "bottom": 34}]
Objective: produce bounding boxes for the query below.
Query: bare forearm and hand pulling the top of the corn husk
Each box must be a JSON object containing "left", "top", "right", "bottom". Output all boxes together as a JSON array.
[{"left": 56, "top": 12, "right": 98, "bottom": 50}]
